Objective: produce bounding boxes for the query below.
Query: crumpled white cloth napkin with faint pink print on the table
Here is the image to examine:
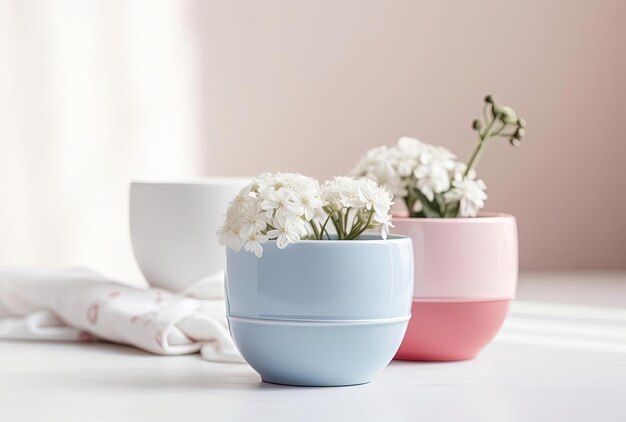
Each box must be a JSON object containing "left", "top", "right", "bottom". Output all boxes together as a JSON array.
[{"left": 0, "top": 269, "right": 242, "bottom": 362}]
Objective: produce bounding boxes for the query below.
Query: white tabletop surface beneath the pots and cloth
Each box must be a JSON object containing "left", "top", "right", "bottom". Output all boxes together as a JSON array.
[{"left": 0, "top": 273, "right": 626, "bottom": 422}]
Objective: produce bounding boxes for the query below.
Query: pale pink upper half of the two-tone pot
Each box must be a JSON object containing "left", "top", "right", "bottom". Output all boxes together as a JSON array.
[{"left": 392, "top": 213, "right": 518, "bottom": 301}]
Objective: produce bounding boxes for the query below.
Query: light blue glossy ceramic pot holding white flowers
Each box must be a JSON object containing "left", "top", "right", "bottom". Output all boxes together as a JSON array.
[{"left": 226, "top": 235, "right": 413, "bottom": 386}]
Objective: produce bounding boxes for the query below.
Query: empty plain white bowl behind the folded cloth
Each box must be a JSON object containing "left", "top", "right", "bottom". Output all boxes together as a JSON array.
[{"left": 130, "top": 177, "right": 251, "bottom": 292}]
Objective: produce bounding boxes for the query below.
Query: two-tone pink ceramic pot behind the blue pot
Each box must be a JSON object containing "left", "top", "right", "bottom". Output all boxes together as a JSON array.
[{"left": 393, "top": 213, "right": 517, "bottom": 361}]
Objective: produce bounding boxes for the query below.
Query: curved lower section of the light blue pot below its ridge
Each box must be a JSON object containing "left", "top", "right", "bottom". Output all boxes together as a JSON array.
[{"left": 229, "top": 318, "right": 408, "bottom": 387}]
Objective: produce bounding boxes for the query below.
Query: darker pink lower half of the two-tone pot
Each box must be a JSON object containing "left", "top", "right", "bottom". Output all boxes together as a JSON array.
[{"left": 394, "top": 300, "right": 511, "bottom": 361}]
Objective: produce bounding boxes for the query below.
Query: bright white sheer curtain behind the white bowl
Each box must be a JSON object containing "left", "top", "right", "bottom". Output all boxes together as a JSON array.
[{"left": 0, "top": 0, "right": 203, "bottom": 280}]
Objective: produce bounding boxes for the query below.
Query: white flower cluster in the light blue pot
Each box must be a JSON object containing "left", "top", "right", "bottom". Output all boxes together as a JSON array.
[{"left": 217, "top": 173, "right": 392, "bottom": 257}]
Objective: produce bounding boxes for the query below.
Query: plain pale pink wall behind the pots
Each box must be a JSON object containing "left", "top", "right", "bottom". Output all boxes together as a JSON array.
[{"left": 192, "top": 0, "right": 626, "bottom": 269}]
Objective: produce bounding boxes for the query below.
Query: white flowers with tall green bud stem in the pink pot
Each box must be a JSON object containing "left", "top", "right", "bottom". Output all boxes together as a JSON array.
[{"left": 352, "top": 95, "right": 526, "bottom": 218}]
